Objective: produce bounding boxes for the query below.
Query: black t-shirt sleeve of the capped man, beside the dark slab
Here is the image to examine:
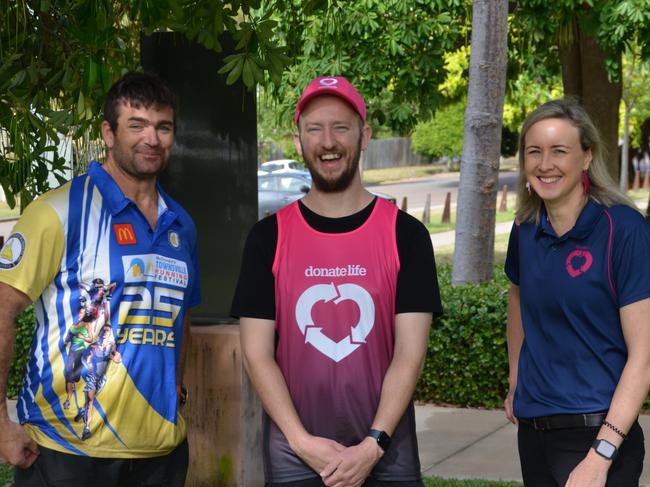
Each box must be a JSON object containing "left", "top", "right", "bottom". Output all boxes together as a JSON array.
[{"left": 230, "top": 215, "right": 278, "bottom": 320}]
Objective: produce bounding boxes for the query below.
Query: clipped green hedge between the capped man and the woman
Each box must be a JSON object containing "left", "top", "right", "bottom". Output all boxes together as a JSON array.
[{"left": 416, "top": 266, "right": 509, "bottom": 408}]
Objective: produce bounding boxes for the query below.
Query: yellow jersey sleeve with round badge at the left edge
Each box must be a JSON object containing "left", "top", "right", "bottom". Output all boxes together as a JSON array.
[{"left": 0, "top": 200, "right": 65, "bottom": 301}]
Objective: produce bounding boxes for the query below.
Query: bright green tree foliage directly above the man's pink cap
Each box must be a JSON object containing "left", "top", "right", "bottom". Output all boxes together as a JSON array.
[{"left": 264, "top": 0, "right": 471, "bottom": 134}]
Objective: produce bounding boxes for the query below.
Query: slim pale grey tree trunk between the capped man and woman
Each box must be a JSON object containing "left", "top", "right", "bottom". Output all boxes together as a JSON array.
[{"left": 452, "top": 0, "right": 508, "bottom": 285}]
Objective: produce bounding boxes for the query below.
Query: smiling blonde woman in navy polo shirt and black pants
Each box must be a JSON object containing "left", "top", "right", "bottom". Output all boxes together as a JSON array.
[{"left": 505, "top": 100, "right": 650, "bottom": 487}]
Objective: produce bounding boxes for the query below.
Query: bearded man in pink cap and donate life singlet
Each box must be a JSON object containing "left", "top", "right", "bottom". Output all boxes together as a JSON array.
[{"left": 232, "top": 77, "right": 442, "bottom": 487}]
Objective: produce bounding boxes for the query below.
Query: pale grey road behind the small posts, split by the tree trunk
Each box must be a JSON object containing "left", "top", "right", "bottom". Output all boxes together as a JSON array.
[{"left": 368, "top": 171, "right": 519, "bottom": 210}]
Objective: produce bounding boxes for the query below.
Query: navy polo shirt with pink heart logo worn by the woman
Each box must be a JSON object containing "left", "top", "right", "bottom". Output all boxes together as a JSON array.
[{"left": 505, "top": 200, "right": 650, "bottom": 418}]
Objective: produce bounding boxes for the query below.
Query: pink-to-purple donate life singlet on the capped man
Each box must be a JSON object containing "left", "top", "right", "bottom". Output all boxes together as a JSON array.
[{"left": 265, "top": 198, "right": 419, "bottom": 482}]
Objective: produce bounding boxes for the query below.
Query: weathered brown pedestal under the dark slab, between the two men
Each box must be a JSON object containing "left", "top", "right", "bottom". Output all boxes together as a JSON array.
[{"left": 182, "top": 325, "right": 264, "bottom": 487}]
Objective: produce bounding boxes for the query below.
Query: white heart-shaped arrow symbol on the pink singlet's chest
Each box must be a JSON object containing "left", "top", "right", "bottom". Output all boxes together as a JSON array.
[{"left": 296, "top": 283, "right": 375, "bottom": 362}]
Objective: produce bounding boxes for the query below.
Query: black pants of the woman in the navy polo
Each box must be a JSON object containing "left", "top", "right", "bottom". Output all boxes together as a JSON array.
[{"left": 517, "top": 421, "right": 645, "bottom": 487}]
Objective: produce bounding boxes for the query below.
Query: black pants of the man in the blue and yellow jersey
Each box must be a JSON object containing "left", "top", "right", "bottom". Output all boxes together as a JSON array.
[{"left": 14, "top": 441, "right": 189, "bottom": 487}]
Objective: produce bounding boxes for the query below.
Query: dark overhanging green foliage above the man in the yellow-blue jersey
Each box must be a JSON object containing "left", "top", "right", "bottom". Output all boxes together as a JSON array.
[{"left": 0, "top": 0, "right": 289, "bottom": 207}]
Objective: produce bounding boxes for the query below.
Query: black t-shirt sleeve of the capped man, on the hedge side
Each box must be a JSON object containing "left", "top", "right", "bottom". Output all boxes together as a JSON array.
[{"left": 395, "top": 210, "right": 442, "bottom": 316}]
